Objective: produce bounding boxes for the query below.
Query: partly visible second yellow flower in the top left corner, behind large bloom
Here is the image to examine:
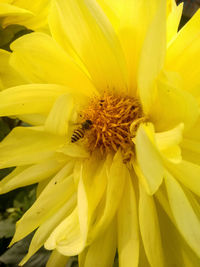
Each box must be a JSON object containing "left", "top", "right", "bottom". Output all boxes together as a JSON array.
[{"left": 0, "top": 0, "right": 51, "bottom": 31}]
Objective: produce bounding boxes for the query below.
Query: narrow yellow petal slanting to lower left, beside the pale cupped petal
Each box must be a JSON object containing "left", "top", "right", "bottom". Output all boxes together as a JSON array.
[{"left": 20, "top": 195, "right": 76, "bottom": 266}]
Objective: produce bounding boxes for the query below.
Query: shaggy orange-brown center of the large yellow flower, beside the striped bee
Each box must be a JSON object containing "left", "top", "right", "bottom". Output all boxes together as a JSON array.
[{"left": 81, "top": 92, "right": 145, "bottom": 161}]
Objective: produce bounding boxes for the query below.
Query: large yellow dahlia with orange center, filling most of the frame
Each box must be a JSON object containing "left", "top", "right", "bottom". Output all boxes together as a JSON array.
[{"left": 0, "top": 0, "right": 200, "bottom": 267}]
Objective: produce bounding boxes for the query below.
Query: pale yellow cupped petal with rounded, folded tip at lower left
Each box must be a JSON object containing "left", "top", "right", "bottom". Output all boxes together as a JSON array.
[{"left": 45, "top": 208, "right": 86, "bottom": 256}]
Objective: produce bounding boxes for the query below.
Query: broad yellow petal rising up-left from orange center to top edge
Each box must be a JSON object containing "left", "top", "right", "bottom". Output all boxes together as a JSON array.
[{"left": 50, "top": 0, "right": 126, "bottom": 90}]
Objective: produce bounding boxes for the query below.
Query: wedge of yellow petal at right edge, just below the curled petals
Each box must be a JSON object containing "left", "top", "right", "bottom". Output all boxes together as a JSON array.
[{"left": 168, "top": 160, "right": 200, "bottom": 196}]
